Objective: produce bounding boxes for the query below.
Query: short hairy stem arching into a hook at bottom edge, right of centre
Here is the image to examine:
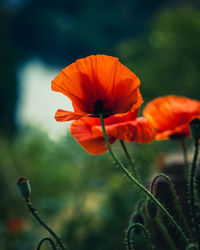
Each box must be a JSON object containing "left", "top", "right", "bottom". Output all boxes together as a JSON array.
[{"left": 126, "top": 223, "right": 153, "bottom": 250}]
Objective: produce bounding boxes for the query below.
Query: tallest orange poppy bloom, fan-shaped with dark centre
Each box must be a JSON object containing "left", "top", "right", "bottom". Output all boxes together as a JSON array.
[{"left": 51, "top": 55, "right": 143, "bottom": 121}]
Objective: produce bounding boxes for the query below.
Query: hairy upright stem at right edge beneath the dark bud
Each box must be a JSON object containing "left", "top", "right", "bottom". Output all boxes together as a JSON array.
[{"left": 189, "top": 140, "right": 200, "bottom": 249}]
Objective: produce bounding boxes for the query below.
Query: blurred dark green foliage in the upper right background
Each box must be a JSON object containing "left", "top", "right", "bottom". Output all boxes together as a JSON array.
[{"left": 116, "top": 5, "right": 200, "bottom": 101}]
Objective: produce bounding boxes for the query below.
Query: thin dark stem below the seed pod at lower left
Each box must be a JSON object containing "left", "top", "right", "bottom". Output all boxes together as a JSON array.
[{"left": 26, "top": 198, "right": 65, "bottom": 250}]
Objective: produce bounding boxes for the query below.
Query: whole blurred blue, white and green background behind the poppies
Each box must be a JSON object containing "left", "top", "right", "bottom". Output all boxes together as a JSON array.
[{"left": 0, "top": 0, "right": 200, "bottom": 250}]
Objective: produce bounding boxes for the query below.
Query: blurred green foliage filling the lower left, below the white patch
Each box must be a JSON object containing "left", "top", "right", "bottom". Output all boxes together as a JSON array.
[{"left": 0, "top": 129, "right": 162, "bottom": 250}]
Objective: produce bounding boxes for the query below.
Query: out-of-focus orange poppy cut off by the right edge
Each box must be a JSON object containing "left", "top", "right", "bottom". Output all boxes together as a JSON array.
[{"left": 143, "top": 95, "right": 200, "bottom": 140}]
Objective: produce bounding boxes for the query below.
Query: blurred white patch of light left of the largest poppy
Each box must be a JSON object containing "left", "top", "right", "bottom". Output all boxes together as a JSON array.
[{"left": 17, "top": 60, "right": 73, "bottom": 139}]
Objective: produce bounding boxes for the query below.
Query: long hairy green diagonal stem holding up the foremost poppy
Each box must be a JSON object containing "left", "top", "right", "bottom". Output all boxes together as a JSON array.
[{"left": 99, "top": 114, "right": 189, "bottom": 245}]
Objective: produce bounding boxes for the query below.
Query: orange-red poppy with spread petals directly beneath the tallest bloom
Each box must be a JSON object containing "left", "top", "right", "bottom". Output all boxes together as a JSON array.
[{"left": 70, "top": 110, "right": 155, "bottom": 154}]
